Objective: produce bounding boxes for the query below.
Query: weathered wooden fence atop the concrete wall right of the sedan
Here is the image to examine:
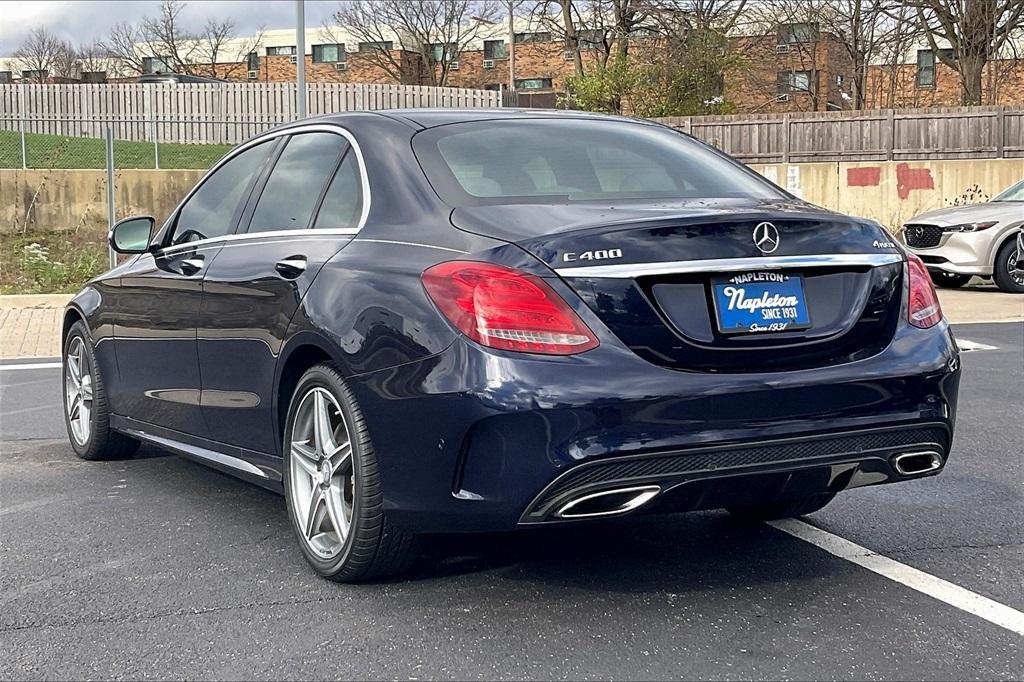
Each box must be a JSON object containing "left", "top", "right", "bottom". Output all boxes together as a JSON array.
[{"left": 656, "top": 106, "right": 1024, "bottom": 164}]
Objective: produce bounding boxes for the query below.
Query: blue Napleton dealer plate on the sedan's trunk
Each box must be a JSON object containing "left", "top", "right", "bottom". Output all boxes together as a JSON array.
[{"left": 712, "top": 271, "right": 811, "bottom": 334}]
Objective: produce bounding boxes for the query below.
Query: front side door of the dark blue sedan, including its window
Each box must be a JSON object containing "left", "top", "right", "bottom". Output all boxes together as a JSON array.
[{"left": 113, "top": 142, "right": 273, "bottom": 436}]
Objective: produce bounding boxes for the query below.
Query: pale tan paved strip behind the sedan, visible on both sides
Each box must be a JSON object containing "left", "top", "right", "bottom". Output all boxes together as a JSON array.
[{"left": 0, "top": 287, "right": 1024, "bottom": 360}]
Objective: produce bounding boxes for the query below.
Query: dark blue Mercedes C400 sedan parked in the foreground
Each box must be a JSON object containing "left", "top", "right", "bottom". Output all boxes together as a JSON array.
[{"left": 63, "top": 110, "right": 959, "bottom": 581}]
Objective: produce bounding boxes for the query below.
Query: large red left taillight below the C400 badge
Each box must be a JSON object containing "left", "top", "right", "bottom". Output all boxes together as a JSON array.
[{"left": 423, "top": 260, "right": 598, "bottom": 355}]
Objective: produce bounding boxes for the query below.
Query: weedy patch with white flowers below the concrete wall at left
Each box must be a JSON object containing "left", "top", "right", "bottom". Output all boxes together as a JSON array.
[{"left": 0, "top": 230, "right": 108, "bottom": 294}]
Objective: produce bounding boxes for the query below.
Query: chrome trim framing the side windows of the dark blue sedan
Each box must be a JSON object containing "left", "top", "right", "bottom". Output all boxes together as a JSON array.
[{"left": 157, "top": 123, "right": 372, "bottom": 253}]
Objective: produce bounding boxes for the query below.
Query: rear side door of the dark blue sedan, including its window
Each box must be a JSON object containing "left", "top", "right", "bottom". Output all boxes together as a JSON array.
[{"left": 199, "top": 129, "right": 364, "bottom": 455}]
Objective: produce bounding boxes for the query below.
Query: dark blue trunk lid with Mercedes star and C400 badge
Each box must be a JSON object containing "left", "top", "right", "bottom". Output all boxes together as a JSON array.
[{"left": 452, "top": 200, "right": 903, "bottom": 372}]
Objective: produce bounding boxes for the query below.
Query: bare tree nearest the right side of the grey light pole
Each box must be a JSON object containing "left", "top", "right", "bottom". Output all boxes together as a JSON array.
[{"left": 324, "top": 0, "right": 502, "bottom": 85}]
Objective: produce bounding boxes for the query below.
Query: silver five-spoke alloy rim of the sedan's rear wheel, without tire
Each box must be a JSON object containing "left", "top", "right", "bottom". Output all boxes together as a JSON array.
[{"left": 289, "top": 386, "right": 355, "bottom": 559}]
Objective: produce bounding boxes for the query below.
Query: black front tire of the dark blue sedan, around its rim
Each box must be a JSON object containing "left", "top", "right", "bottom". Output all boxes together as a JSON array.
[{"left": 60, "top": 322, "right": 139, "bottom": 461}]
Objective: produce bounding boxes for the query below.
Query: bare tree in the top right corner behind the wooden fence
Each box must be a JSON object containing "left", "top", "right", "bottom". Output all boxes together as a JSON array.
[{"left": 903, "top": 0, "right": 1024, "bottom": 104}]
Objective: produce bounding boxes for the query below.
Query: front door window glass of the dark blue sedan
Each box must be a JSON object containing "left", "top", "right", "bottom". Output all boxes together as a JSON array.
[{"left": 171, "top": 141, "right": 273, "bottom": 244}]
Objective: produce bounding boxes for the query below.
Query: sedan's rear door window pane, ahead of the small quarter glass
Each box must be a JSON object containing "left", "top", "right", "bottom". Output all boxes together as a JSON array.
[{"left": 249, "top": 132, "right": 347, "bottom": 232}]
